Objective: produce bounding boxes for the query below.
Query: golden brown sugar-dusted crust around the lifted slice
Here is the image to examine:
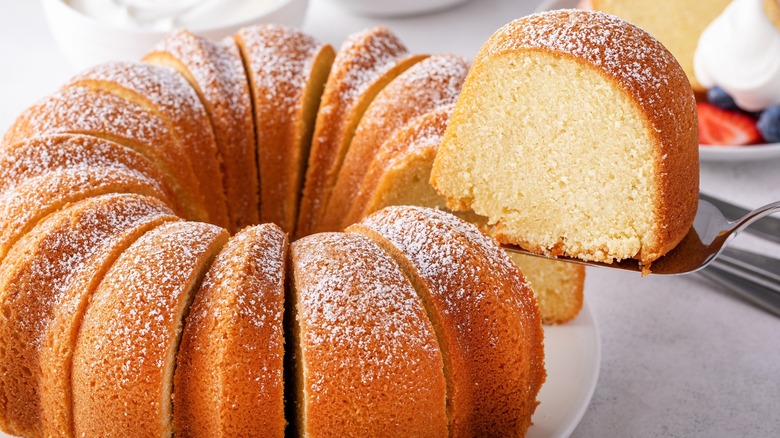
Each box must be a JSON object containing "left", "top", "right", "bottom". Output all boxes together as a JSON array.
[{"left": 431, "top": 10, "right": 699, "bottom": 265}]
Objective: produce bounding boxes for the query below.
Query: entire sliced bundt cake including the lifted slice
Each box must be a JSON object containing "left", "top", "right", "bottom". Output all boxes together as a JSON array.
[{"left": 0, "top": 11, "right": 697, "bottom": 436}]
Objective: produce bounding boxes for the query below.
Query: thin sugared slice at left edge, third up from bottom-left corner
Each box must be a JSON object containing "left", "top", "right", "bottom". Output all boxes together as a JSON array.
[{"left": 0, "top": 134, "right": 184, "bottom": 215}]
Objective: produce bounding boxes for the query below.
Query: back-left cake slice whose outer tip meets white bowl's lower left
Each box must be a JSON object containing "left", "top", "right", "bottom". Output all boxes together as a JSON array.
[{"left": 65, "top": 62, "right": 230, "bottom": 231}]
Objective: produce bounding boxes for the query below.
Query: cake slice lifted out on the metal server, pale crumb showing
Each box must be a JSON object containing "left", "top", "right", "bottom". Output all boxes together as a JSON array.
[{"left": 431, "top": 10, "right": 699, "bottom": 268}]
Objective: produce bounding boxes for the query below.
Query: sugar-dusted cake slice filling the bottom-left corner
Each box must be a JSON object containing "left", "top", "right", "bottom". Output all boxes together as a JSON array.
[{"left": 0, "top": 194, "right": 177, "bottom": 436}]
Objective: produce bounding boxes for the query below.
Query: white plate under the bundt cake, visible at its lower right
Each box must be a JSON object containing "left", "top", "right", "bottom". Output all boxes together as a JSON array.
[{"left": 527, "top": 301, "right": 601, "bottom": 438}]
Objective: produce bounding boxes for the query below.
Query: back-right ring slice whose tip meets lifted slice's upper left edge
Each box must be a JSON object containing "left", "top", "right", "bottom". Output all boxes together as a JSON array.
[{"left": 318, "top": 54, "right": 469, "bottom": 231}]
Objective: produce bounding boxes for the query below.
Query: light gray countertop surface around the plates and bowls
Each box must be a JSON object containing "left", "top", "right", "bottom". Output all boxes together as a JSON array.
[{"left": 0, "top": 0, "right": 780, "bottom": 437}]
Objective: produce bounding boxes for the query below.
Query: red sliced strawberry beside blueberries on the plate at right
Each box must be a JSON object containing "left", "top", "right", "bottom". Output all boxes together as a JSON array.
[{"left": 696, "top": 102, "right": 761, "bottom": 146}]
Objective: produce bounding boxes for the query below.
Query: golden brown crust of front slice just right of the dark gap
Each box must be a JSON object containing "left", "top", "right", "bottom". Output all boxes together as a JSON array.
[{"left": 290, "top": 233, "right": 447, "bottom": 437}]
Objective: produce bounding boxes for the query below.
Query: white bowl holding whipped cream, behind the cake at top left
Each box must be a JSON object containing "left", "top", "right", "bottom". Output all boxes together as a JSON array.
[{"left": 43, "top": 0, "right": 309, "bottom": 69}]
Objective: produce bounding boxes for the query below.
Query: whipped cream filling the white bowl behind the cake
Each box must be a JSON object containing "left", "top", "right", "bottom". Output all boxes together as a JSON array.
[{"left": 66, "top": 0, "right": 287, "bottom": 31}]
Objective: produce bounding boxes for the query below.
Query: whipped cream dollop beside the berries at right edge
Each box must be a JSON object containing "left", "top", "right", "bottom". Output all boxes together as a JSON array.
[{"left": 693, "top": 0, "right": 780, "bottom": 111}]
